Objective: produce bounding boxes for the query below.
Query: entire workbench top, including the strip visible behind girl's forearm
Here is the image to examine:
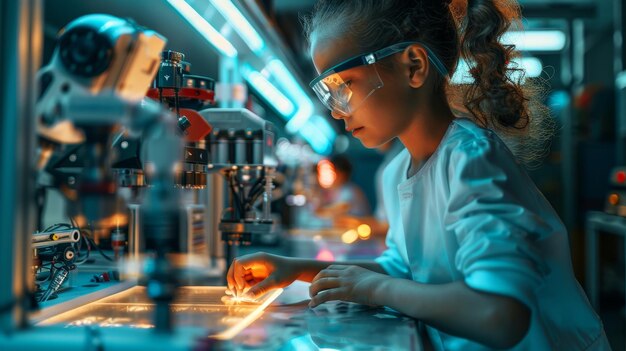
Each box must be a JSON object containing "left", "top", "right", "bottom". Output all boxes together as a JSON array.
[{"left": 26, "top": 233, "right": 422, "bottom": 350}]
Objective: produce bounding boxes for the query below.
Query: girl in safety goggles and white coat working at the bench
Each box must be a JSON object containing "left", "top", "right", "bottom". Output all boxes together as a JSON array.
[{"left": 228, "top": 0, "right": 609, "bottom": 351}]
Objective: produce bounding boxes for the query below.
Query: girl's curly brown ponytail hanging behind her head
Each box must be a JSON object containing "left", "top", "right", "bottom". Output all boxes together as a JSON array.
[{"left": 450, "top": 0, "right": 555, "bottom": 168}]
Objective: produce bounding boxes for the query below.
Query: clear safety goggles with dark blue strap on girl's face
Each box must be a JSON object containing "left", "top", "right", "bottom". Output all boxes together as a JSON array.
[{"left": 309, "top": 41, "right": 448, "bottom": 115}]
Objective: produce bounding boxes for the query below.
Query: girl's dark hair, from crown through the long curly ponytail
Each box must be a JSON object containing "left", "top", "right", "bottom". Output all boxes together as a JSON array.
[{"left": 303, "top": 0, "right": 555, "bottom": 167}]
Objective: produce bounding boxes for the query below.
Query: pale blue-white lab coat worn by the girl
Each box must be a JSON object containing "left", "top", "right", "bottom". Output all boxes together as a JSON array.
[{"left": 377, "top": 118, "right": 610, "bottom": 351}]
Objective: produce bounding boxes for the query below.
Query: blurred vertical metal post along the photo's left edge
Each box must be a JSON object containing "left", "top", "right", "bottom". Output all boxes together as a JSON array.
[{"left": 0, "top": 0, "right": 43, "bottom": 333}]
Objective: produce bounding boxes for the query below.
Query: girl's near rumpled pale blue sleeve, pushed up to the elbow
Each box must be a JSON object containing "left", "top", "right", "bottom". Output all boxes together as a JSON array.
[{"left": 444, "top": 138, "right": 551, "bottom": 306}]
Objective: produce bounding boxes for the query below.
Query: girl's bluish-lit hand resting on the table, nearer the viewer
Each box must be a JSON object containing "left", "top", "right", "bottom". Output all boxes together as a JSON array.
[{"left": 309, "top": 265, "right": 389, "bottom": 308}]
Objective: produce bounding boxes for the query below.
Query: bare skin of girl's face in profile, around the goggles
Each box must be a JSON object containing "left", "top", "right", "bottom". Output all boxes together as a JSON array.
[{"left": 311, "top": 34, "right": 416, "bottom": 148}]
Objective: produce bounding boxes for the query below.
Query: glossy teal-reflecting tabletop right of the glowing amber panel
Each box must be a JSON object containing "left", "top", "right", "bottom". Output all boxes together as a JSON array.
[{"left": 226, "top": 282, "right": 422, "bottom": 350}]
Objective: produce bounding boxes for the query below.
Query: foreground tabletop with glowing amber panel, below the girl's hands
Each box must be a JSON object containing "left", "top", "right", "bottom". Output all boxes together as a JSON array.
[{"left": 35, "top": 282, "right": 422, "bottom": 350}]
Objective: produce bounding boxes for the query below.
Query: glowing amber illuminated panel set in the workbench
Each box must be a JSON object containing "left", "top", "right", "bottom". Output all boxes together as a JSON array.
[{"left": 39, "top": 286, "right": 282, "bottom": 340}]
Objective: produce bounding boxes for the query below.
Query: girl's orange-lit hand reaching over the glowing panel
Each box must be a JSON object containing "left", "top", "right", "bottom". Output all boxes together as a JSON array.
[{"left": 226, "top": 252, "right": 300, "bottom": 299}]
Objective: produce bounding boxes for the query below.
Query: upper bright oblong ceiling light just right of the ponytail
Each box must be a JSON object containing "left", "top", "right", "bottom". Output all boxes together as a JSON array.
[{"left": 500, "top": 30, "right": 566, "bottom": 51}]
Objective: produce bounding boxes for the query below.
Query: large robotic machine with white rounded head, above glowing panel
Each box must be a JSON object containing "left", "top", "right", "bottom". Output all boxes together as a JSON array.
[{"left": 20, "top": 9, "right": 277, "bottom": 340}]
